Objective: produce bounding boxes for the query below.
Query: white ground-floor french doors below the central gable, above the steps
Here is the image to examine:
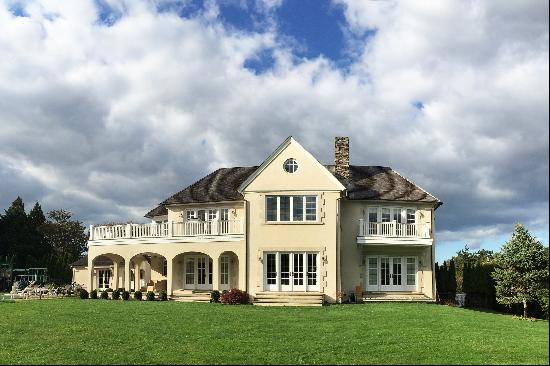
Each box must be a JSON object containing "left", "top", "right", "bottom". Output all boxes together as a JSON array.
[{"left": 264, "top": 252, "right": 320, "bottom": 291}]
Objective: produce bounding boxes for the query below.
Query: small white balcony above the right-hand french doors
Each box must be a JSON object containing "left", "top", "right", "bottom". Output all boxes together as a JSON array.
[{"left": 357, "top": 219, "right": 433, "bottom": 245}]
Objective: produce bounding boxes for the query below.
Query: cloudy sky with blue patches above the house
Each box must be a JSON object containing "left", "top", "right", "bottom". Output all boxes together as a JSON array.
[{"left": 0, "top": 0, "right": 549, "bottom": 261}]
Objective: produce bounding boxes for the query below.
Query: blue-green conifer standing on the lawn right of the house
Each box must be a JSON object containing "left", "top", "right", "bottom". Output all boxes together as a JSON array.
[{"left": 493, "top": 224, "right": 548, "bottom": 317}]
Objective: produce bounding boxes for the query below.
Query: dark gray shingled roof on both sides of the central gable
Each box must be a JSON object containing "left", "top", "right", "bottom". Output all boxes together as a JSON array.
[{"left": 145, "top": 165, "right": 441, "bottom": 218}]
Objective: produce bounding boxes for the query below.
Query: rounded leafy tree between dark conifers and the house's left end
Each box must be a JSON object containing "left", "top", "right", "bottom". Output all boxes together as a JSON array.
[{"left": 41, "top": 210, "right": 88, "bottom": 282}]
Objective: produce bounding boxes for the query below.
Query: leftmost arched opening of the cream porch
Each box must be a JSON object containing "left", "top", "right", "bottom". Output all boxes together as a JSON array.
[{"left": 90, "top": 253, "right": 125, "bottom": 291}]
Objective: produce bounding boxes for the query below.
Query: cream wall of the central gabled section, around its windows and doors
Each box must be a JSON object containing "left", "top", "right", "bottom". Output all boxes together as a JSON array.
[{"left": 243, "top": 141, "right": 343, "bottom": 302}]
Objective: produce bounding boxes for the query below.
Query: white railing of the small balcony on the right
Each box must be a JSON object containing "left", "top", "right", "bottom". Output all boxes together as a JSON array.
[{"left": 359, "top": 219, "right": 431, "bottom": 239}]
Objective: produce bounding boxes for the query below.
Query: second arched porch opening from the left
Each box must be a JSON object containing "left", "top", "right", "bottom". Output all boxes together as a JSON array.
[{"left": 129, "top": 252, "right": 168, "bottom": 292}]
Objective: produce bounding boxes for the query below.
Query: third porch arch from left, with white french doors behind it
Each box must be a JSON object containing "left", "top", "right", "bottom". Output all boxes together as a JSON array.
[{"left": 172, "top": 252, "right": 214, "bottom": 291}]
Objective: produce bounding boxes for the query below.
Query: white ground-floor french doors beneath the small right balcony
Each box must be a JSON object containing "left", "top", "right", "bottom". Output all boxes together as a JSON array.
[{"left": 365, "top": 256, "right": 417, "bottom": 292}]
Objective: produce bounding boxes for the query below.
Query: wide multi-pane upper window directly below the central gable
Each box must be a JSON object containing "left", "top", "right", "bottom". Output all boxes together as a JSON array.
[{"left": 265, "top": 196, "right": 317, "bottom": 222}]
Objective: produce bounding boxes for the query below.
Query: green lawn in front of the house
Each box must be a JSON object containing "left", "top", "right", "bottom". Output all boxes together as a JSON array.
[{"left": 0, "top": 299, "right": 548, "bottom": 364}]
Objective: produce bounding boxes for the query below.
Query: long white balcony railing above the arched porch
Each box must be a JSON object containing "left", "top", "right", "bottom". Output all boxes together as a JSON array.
[{"left": 90, "top": 220, "right": 243, "bottom": 240}]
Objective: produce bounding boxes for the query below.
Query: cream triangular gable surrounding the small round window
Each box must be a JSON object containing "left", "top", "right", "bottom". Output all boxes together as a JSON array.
[{"left": 239, "top": 137, "right": 345, "bottom": 192}]
